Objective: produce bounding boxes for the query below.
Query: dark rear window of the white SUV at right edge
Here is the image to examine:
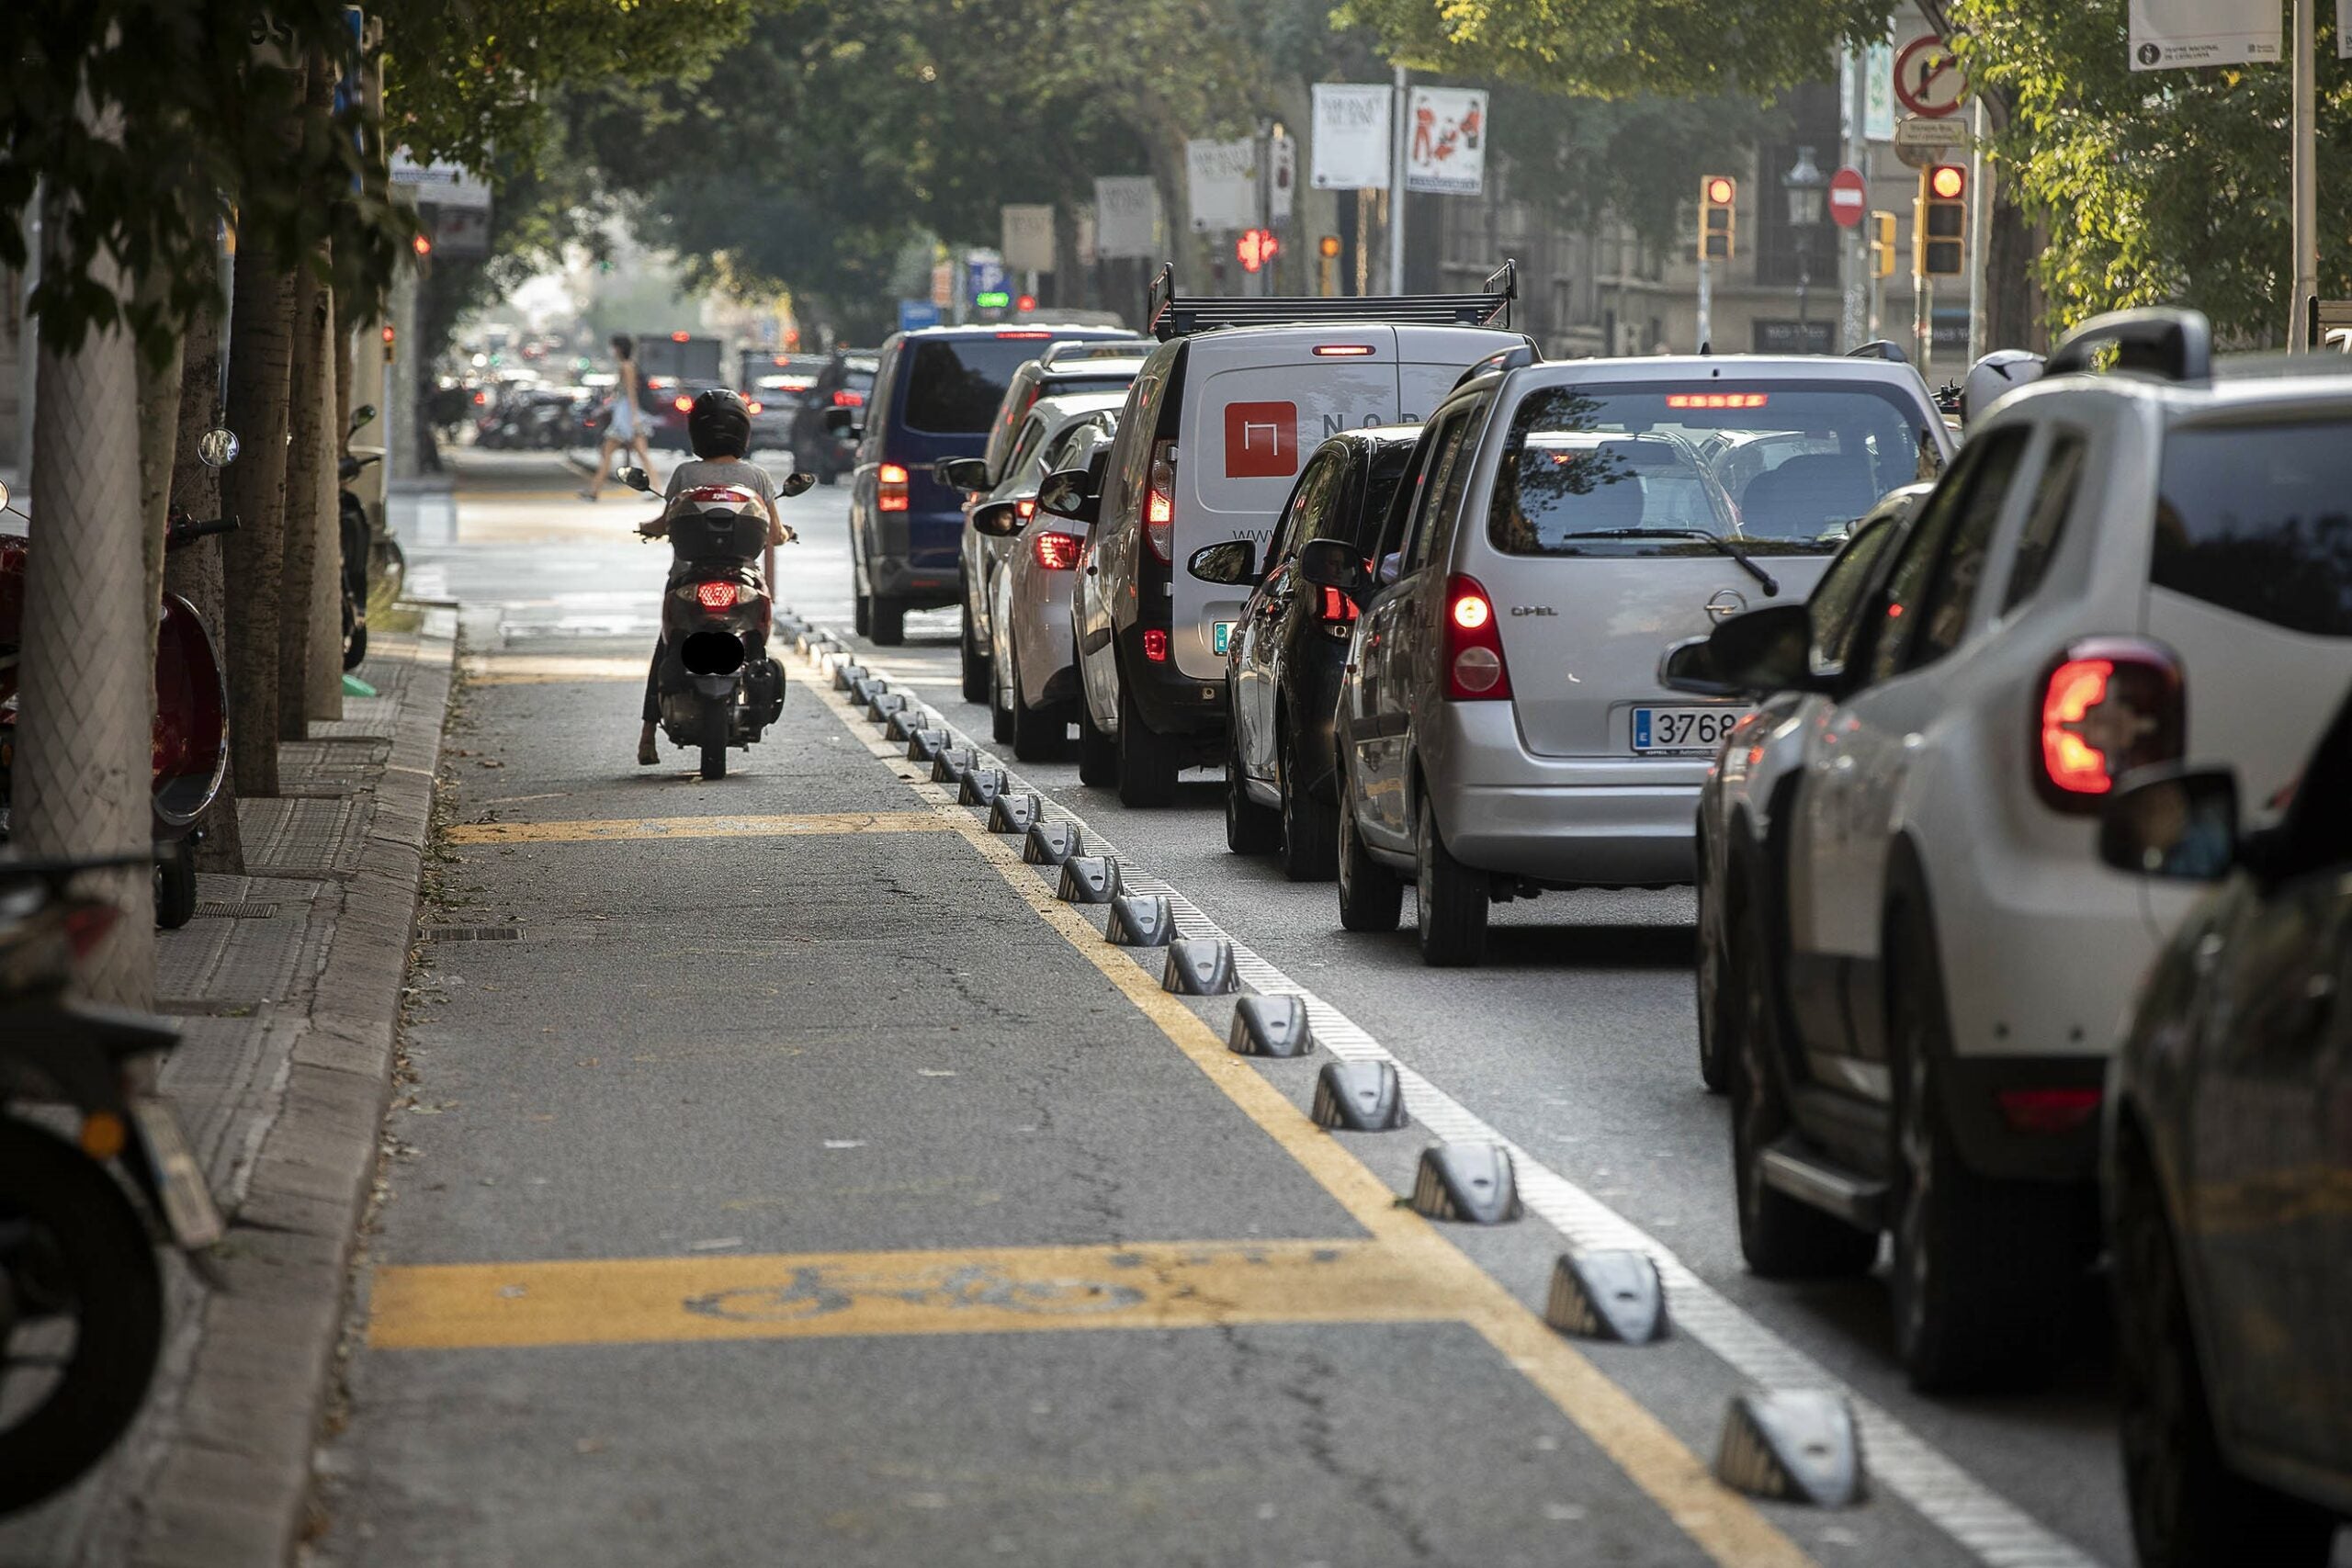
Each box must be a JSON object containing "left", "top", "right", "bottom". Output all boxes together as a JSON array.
[{"left": 2150, "top": 423, "right": 2352, "bottom": 637}]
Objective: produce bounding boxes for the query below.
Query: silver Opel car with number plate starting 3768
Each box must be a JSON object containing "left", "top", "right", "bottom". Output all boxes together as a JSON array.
[{"left": 1301, "top": 355, "right": 1952, "bottom": 964}]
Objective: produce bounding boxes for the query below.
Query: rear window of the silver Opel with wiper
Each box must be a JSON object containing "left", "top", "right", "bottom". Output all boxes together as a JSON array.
[{"left": 1487, "top": 381, "right": 1938, "bottom": 555}]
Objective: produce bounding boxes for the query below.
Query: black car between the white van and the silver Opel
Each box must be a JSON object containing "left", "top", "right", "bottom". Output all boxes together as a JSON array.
[{"left": 1190, "top": 425, "right": 1420, "bottom": 882}]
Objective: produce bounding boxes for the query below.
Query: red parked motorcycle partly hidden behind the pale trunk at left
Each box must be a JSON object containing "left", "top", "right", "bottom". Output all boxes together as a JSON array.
[{"left": 0, "top": 442, "right": 238, "bottom": 931}]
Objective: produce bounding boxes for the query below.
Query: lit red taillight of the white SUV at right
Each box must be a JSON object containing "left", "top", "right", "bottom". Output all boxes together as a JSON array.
[{"left": 2032, "top": 637, "right": 2185, "bottom": 811}]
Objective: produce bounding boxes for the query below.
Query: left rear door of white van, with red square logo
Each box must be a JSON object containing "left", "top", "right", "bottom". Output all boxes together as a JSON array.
[{"left": 1169, "top": 322, "right": 1392, "bottom": 680}]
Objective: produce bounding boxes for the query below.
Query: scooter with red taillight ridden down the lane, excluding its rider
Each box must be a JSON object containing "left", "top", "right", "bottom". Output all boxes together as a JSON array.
[{"left": 621, "top": 468, "right": 816, "bottom": 778}]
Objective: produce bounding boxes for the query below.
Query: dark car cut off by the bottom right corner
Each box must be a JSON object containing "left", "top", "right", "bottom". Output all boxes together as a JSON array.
[{"left": 2100, "top": 682, "right": 2352, "bottom": 1568}]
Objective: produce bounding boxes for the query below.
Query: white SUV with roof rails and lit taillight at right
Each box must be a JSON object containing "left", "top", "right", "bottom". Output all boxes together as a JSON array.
[{"left": 1668, "top": 310, "right": 2352, "bottom": 1389}]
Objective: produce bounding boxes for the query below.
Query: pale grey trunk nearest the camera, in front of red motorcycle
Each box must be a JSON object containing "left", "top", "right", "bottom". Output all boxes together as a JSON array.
[{"left": 9, "top": 186, "right": 155, "bottom": 1006}]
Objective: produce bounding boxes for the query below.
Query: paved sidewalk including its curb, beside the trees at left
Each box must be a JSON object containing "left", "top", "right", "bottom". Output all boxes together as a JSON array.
[{"left": 0, "top": 609, "right": 457, "bottom": 1568}]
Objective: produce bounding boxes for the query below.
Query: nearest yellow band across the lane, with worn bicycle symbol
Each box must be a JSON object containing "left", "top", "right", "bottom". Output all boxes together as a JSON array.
[{"left": 367, "top": 1241, "right": 1463, "bottom": 1349}]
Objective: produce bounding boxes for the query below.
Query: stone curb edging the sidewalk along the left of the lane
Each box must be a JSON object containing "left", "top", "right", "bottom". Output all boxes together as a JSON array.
[{"left": 130, "top": 639, "right": 457, "bottom": 1568}]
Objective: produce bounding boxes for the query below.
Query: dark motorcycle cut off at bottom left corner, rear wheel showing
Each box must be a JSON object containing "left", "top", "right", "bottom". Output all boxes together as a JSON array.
[{"left": 0, "top": 853, "right": 221, "bottom": 1514}]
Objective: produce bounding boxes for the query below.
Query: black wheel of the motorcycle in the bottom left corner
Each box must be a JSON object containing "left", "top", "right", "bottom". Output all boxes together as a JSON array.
[{"left": 0, "top": 1119, "right": 163, "bottom": 1514}]
